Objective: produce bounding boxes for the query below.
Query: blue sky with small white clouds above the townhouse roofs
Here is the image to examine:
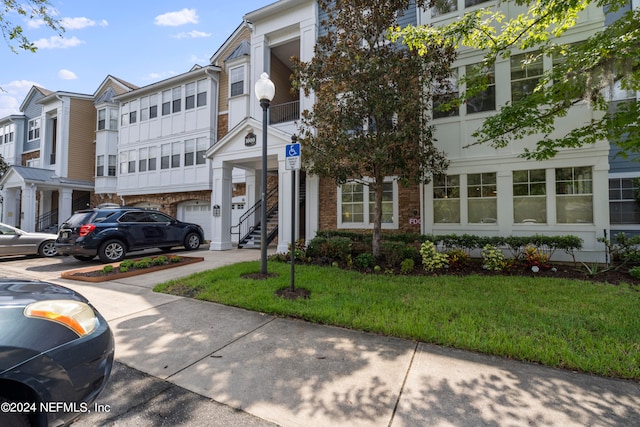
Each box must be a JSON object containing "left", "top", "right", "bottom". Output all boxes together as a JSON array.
[{"left": 0, "top": 0, "right": 276, "bottom": 118}]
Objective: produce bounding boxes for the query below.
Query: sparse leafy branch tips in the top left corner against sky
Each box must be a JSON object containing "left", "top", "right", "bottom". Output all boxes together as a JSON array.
[{"left": 0, "top": 0, "right": 64, "bottom": 53}]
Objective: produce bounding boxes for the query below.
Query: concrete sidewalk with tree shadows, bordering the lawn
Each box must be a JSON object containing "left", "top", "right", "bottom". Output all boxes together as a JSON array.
[{"left": 38, "top": 250, "right": 640, "bottom": 427}]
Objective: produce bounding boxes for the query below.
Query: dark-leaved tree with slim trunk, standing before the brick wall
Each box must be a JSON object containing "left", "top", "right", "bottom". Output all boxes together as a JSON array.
[{"left": 294, "top": 0, "right": 454, "bottom": 256}]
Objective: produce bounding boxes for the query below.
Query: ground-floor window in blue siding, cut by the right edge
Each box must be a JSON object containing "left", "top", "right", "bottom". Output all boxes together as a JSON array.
[{"left": 609, "top": 178, "right": 640, "bottom": 225}]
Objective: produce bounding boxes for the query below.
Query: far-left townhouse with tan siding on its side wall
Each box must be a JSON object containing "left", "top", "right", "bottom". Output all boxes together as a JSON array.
[{"left": 0, "top": 87, "right": 95, "bottom": 231}]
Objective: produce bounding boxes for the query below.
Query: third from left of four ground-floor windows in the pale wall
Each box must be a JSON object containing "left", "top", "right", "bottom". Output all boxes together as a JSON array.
[{"left": 513, "top": 169, "right": 547, "bottom": 224}]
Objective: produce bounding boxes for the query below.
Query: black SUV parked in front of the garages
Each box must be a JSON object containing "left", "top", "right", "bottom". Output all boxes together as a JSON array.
[{"left": 56, "top": 206, "right": 204, "bottom": 263}]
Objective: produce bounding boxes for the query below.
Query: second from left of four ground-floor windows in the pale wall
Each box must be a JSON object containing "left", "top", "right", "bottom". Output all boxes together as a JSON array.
[{"left": 467, "top": 172, "right": 498, "bottom": 224}]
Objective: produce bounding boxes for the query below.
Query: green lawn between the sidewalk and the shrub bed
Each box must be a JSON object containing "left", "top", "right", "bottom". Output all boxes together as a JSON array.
[{"left": 154, "top": 262, "right": 640, "bottom": 381}]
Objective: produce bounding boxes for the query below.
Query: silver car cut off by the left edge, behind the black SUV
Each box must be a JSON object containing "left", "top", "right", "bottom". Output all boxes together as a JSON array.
[{"left": 0, "top": 223, "right": 58, "bottom": 257}]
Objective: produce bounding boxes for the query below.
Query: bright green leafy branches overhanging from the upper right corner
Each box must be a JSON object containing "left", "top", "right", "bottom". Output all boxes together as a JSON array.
[{"left": 392, "top": 0, "right": 640, "bottom": 160}]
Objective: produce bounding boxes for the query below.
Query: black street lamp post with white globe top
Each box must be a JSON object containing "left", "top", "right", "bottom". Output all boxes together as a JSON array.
[{"left": 255, "top": 73, "right": 276, "bottom": 274}]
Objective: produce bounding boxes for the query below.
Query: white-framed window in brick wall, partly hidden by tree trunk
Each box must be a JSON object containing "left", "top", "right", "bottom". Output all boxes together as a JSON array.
[{"left": 338, "top": 180, "right": 398, "bottom": 228}]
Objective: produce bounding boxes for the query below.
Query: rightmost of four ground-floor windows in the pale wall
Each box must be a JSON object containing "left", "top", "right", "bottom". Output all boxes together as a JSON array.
[{"left": 556, "top": 167, "right": 593, "bottom": 224}]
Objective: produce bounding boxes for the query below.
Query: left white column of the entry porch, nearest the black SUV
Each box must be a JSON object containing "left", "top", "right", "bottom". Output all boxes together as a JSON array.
[{"left": 209, "top": 163, "right": 233, "bottom": 251}]
